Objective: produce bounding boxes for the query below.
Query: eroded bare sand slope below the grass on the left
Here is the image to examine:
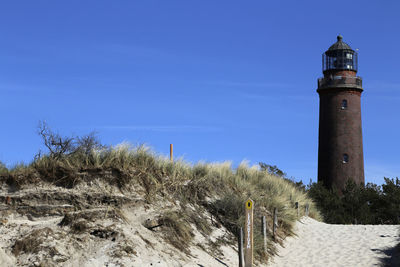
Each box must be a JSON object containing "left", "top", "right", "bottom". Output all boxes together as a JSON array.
[{"left": 0, "top": 180, "right": 238, "bottom": 267}]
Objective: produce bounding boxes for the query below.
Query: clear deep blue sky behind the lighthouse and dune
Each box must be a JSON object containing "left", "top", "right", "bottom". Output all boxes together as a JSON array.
[{"left": 0, "top": 0, "right": 400, "bottom": 184}]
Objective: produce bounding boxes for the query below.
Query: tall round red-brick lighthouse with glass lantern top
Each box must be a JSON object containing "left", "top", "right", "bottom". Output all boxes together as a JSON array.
[{"left": 317, "top": 35, "right": 364, "bottom": 191}]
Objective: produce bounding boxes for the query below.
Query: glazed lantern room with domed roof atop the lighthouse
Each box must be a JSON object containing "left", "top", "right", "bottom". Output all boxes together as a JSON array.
[{"left": 322, "top": 35, "right": 358, "bottom": 74}]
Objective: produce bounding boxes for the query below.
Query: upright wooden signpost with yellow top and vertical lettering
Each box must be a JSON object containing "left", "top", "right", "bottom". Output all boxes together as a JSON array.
[{"left": 244, "top": 198, "right": 254, "bottom": 267}]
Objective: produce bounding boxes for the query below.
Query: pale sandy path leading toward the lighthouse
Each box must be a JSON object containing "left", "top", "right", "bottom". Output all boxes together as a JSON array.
[{"left": 268, "top": 218, "right": 400, "bottom": 267}]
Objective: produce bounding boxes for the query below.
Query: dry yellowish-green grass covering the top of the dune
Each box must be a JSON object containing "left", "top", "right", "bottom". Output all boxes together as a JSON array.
[{"left": 0, "top": 144, "right": 321, "bottom": 261}]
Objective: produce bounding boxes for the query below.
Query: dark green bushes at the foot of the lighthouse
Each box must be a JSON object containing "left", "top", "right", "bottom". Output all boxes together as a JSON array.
[{"left": 308, "top": 178, "right": 400, "bottom": 224}]
